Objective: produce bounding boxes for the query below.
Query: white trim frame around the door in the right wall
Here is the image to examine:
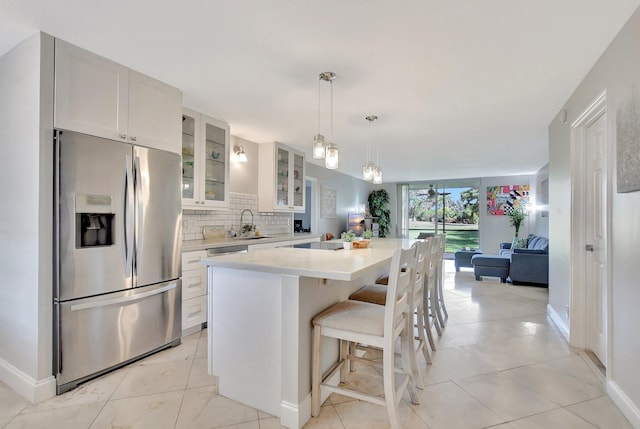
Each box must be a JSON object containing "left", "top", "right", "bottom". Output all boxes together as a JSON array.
[{"left": 569, "top": 90, "right": 612, "bottom": 366}]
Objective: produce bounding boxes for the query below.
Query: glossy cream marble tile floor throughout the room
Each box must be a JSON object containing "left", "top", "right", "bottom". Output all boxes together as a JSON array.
[{"left": 0, "top": 261, "right": 632, "bottom": 429}]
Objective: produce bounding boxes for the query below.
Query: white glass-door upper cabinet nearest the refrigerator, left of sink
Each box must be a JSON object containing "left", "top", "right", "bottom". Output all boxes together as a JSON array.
[{"left": 182, "top": 109, "right": 230, "bottom": 210}]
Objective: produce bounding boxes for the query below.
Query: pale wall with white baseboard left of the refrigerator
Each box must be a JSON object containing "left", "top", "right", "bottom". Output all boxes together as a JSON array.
[{"left": 0, "top": 33, "right": 55, "bottom": 401}]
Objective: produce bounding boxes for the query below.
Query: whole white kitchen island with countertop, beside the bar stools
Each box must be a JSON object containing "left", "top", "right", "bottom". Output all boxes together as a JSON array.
[{"left": 202, "top": 239, "right": 413, "bottom": 429}]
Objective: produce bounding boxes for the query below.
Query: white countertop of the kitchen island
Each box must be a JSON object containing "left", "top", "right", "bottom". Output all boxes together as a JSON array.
[{"left": 202, "top": 238, "right": 415, "bottom": 281}]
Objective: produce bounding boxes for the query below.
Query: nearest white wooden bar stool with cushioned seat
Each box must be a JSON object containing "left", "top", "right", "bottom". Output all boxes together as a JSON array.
[{"left": 311, "top": 248, "right": 419, "bottom": 429}]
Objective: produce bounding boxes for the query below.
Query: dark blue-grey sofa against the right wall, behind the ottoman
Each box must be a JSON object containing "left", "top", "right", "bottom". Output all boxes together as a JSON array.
[{"left": 500, "top": 234, "right": 549, "bottom": 286}]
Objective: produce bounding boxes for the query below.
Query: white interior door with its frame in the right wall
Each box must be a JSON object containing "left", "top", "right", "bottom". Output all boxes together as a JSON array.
[{"left": 570, "top": 93, "right": 610, "bottom": 368}]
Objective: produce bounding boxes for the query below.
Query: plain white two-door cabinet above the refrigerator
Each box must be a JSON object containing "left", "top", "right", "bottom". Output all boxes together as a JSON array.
[{"left": 54, "top": 39, "right": 182, "bottom": 153}]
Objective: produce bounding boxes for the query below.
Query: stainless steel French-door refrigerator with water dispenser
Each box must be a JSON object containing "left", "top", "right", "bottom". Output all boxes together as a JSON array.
[{"left": 53, "top": 131, "right": 182, "bottom": 394}]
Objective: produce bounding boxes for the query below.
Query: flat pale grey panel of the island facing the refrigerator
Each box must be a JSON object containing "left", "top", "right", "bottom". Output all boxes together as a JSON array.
[{"left": 208, "top": 267, "right": 282, "bottom": 416}]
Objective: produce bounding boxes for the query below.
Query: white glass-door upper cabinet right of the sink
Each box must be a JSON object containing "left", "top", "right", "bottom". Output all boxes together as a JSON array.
[{"left": 258, "top": 142, "right": 305, "bottom": 213}]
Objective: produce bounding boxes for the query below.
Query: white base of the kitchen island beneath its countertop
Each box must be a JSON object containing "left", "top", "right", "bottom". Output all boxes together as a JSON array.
[{"left": 208, "top": 267, "right": 386, "bottom": 428}]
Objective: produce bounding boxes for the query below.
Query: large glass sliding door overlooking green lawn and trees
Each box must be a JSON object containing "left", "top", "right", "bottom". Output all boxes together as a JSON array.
[{"left": 402, "top": 181, "right": 480, "bottom": 253}]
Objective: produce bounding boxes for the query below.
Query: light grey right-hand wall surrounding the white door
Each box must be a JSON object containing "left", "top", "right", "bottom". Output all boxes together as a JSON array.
[{"left": 549, "top": 5, "right": 640, "bottom": 425}]
